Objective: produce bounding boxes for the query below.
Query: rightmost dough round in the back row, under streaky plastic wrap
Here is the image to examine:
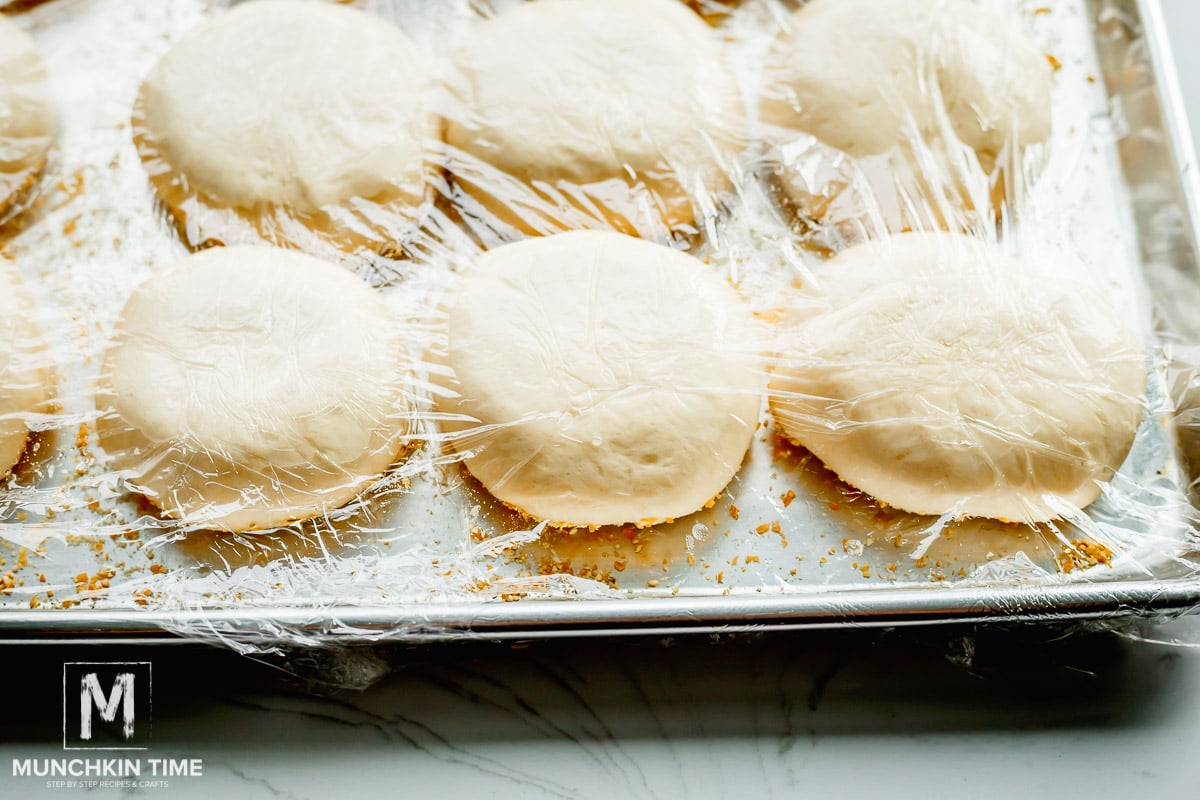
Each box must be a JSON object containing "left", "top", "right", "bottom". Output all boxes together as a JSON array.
[{"left": 761, "top": 0, "right": 1052, "bottom": 233}]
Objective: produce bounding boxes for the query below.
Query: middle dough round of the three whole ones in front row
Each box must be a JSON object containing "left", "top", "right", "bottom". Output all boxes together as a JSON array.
[{"left": 439, "top": 231, "right": 761, "bottom": 525}]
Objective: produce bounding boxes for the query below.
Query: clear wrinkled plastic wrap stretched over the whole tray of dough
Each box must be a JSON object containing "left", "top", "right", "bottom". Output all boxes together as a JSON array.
[{"left": 0, "top": 0, "right": 1200, "bottom": 649}]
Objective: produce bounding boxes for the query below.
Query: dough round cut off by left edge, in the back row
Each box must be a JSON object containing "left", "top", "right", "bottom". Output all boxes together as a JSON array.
[{"left": 0, "top": 14, "right": 53, "bottom": 213}]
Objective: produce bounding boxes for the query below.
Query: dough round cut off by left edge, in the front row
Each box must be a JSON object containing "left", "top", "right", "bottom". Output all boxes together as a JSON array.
[{"left": 0, "top": 264, "right": 53, "bottom": 477}]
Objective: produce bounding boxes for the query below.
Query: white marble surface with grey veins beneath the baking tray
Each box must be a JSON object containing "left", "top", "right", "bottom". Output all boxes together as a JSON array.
[{"left": 7, "top": 0, "right": 1200, "bottom": 800}]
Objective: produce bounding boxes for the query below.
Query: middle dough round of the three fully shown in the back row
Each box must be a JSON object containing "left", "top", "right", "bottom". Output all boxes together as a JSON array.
[{"left": 446, "top": 0, "right": 744, "bottom": 233}]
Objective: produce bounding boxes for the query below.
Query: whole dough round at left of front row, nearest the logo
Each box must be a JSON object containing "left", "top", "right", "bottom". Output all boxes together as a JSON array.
[{"left": 97, "top": 247, "right": 408, "bottom": 530}]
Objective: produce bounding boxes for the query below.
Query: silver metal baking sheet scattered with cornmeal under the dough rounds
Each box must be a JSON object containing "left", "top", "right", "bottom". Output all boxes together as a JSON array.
[{"left": 0, "top": 0, "right": 1200, "bottom": 644}]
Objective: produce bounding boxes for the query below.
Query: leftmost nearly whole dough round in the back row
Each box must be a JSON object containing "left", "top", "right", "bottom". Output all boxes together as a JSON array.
[{"left": 133, "top": 0, "right": 438, "bottom": 255}]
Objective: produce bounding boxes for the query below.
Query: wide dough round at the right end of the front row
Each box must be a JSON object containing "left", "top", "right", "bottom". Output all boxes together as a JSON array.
[{"left": 770, "top": 234, "right": 1146, "bottom": 522}]
